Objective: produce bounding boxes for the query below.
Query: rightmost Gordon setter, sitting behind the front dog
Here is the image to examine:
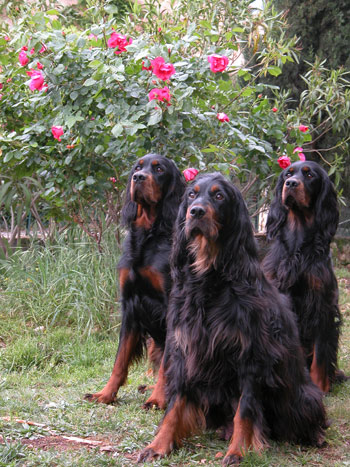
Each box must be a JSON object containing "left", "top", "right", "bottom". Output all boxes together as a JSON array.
[{"left": 263, "top": 161, "right": 346, "bottom": 392}]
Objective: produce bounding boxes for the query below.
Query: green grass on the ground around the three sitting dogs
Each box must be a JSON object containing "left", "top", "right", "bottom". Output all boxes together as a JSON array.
[{"left": 0, "top": 236, "right": 350, "bottom": 467}]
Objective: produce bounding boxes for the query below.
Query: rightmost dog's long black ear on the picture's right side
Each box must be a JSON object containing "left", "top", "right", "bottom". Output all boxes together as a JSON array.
[{"left": 315, "top": 169, "right": 339, "bottom": 243}]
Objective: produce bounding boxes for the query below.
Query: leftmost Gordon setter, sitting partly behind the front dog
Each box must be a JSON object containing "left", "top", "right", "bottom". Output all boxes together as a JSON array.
[{"left": 85, "top": 154, "right": 185, "bottom": 408}]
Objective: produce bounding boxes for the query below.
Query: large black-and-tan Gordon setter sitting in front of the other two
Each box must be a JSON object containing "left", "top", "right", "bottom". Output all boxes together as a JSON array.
[{"left": 139, "top": 173, "right": 326, "bottom": 465}]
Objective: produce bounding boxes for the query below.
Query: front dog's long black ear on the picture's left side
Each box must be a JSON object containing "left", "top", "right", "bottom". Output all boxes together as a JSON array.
[{"left": 170, "top": 198, "right": 187, "bottom": 280}]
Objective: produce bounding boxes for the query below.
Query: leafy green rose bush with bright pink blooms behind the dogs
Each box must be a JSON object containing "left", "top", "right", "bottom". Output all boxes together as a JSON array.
[{"left": 0, "top": 0, "right": 345, "bottom": 241}]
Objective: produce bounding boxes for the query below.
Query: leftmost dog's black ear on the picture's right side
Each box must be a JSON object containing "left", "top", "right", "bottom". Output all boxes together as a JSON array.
[{"left": 162, "top": 160, "right": 186, "bottom": 228}]
